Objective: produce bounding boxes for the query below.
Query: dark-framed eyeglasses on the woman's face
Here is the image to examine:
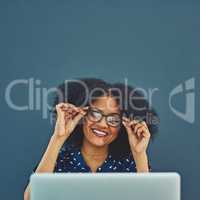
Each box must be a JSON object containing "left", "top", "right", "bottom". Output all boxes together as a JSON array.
[{"left": 87, "top": 107, "right": 122, "bottom": 127}]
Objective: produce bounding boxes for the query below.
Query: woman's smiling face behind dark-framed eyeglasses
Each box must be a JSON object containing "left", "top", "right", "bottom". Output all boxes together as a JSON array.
[{"left": 83, "top": 96, "right": 120, "bottom": 147}]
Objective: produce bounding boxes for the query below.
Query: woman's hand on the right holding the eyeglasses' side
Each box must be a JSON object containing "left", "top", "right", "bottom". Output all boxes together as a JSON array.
[{"left": 123, "top": 117, "right": 151, "bottom": 154}]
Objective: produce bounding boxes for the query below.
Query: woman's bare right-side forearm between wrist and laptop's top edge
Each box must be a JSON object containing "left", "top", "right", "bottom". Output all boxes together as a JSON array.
[{"left": 132, "top": 152, "right": 149, "bottom": 172}]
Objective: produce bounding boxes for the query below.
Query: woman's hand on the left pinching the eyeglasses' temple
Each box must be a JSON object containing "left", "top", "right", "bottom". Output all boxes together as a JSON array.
[{"left": 54, "top": 103, "right": 87, "bottom": 139}]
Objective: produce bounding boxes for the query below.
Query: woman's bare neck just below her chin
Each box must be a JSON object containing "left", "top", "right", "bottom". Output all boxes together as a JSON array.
[{"left": 81, "top": 138, "right": 108, "bottom": 160}]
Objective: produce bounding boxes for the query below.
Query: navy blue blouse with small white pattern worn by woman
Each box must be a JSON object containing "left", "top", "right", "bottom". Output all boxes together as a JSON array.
[{"left": 54, "top": 146, "right": 136, "bottom": 173}]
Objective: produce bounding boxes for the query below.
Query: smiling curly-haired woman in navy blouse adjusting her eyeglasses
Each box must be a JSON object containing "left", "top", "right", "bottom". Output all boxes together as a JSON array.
[{"left": 24, "top": 78, "right": 158, "bottom": 200}]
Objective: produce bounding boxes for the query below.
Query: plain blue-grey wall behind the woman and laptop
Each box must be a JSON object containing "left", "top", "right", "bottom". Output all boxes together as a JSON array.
[{"left": 0, "top": 0, "right": 200, "bottom": 200}]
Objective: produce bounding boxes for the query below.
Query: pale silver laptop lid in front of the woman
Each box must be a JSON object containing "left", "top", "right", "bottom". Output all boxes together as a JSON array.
[{"left": 30, "top": 173, "right": 180, "bottom": 200}]
